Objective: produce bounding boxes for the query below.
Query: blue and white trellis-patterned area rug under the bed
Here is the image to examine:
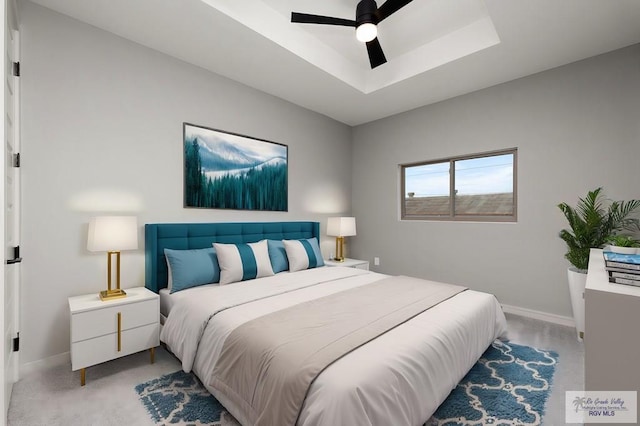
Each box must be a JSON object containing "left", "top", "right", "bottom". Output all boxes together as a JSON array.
[{"left": 136, "top": 341, "right": 558, "bottom": 426}]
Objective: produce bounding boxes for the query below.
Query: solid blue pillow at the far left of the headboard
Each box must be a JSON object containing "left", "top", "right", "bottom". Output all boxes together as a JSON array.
[{"left": 164, "top": 247, "right": 220, "bottom": 293}]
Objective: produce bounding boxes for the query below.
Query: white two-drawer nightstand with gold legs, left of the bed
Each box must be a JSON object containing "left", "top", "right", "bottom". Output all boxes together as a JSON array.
[{"left": 69, "top": 287, "right": 160, "bottom": 386}]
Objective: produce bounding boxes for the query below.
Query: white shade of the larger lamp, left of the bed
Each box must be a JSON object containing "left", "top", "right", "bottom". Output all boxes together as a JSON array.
[{"left": 87, "top": 216, "right": 138, "bottom": 251}]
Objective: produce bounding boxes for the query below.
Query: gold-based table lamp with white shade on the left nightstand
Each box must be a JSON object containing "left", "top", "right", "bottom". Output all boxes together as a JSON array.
[{"left": 87, "top": 216, "right": 138, "bottom": 300}]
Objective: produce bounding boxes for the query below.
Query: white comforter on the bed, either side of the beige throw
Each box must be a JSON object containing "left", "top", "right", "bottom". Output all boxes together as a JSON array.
[{"left": 160, "top": 267, "right": 506, "bottom": 426}]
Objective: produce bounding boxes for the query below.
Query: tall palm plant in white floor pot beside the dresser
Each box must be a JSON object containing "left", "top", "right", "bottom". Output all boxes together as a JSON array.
[{"left": 558, "top": 188, "right": 640, "bottom": 341}]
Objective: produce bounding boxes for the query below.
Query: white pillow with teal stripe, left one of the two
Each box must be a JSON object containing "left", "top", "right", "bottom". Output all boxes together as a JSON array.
[{"left": 213, "top": 240, "right": 273, "bottom": 284}]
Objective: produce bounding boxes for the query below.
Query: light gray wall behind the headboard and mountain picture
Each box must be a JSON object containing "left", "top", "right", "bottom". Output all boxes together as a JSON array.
[{"left": 20, "top": 2, "right": 351, "bottom": 364}]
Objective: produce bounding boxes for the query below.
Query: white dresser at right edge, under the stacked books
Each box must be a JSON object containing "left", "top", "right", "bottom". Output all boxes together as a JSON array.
[{"left": 584, "top": 249, "right": 640, "bottom": 425}]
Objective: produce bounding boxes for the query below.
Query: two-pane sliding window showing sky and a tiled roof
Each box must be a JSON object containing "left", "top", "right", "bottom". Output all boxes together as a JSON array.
[{"left": 400, "top": 148, "right": 517, "bottom": 222}]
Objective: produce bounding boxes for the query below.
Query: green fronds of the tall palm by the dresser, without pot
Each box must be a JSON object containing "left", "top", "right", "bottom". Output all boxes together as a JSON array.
[{"left": 558, "top": 188, "right": 640, "bottom": 271}]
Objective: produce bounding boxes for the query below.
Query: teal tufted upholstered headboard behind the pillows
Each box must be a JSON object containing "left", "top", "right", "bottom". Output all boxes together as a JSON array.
[{"left": 144, "top": 222, "right": 320, "bottom": 293}]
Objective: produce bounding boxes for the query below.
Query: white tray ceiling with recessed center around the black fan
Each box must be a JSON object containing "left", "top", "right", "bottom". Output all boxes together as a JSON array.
[{"left": 26, "top": 0, "right": 640, "bottom": 125}]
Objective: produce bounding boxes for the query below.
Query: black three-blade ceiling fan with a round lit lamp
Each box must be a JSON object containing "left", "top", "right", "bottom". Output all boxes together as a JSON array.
[{"left": 291, "top": 0, "right": 412, "bottom": 69}]
